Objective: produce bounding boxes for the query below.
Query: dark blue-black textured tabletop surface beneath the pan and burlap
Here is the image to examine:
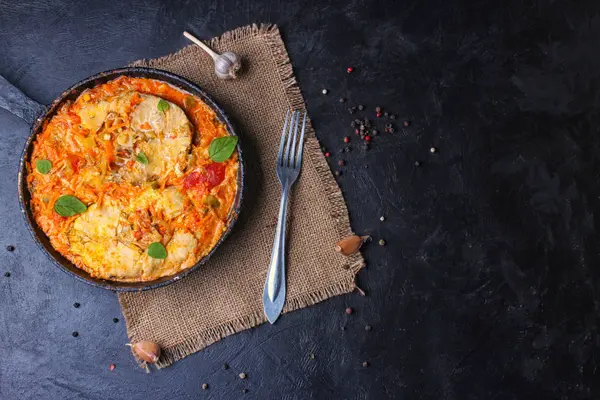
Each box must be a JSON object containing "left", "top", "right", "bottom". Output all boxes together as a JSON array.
[{"left": 0, "top": 0, "right": 600, "bottom": 400}]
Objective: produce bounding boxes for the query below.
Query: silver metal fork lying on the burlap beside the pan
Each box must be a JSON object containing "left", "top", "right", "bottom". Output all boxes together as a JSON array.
[{"left": 263, "top": 111, "right": 306, "bottom": 323}]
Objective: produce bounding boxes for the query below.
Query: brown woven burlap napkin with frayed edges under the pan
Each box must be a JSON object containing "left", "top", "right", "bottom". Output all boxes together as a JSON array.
[{"left": 119, "top": 25, "right": 364, "bottom": 367}]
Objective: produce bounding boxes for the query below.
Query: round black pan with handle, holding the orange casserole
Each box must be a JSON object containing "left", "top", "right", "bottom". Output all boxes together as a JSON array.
[{"left": 0, "top": 67, "right": 244, "bottom": 292}]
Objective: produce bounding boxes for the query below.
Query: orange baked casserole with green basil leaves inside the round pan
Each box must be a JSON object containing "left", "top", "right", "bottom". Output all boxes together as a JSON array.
[{"left": 27, "top": 76, "right": 239, "bottom": 282}]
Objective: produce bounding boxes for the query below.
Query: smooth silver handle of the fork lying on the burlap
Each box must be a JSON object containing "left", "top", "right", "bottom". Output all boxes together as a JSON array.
[{"left": 263, "top": 185, "right": 290, "bottom": 323}]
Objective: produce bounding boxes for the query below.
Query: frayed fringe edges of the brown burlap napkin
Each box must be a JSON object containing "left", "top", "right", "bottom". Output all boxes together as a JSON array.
[{"left": 119, "top": 24, "right": 365, "bottom": 369}]
